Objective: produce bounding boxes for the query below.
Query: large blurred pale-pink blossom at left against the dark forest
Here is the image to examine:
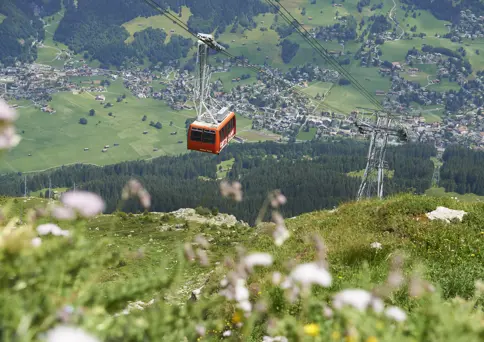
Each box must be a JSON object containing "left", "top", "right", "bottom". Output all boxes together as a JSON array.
[{"left": 61, "top": 191, "right": 106, "bottom": 217}]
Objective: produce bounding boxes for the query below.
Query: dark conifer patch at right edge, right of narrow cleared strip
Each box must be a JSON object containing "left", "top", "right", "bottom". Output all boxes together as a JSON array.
[{"left": 440, "top": 146, "right": 484, "bottom": 195}]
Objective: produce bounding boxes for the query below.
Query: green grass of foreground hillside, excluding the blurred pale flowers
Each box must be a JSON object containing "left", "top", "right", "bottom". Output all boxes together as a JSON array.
[{"left": 2, "top": 195, "right": 484, "bottom": 341}]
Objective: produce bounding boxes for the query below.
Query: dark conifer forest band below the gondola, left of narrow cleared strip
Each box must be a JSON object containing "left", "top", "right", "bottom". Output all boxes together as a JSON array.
[{"left": 0, "top": 140, "right": 435, "bottom": 223}]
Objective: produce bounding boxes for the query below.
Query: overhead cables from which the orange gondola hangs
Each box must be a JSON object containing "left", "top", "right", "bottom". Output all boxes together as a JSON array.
[{"left": 143, "top": 0, "right": 352, "bottom": 113}]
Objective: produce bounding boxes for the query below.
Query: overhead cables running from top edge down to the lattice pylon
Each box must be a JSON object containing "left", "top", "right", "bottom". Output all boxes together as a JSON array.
[{"left": 265, "top": 0, "right": 383, "bottom": 109}]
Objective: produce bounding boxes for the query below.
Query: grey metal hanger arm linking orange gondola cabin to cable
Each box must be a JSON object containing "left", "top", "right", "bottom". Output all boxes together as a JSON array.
[{"left": 193, "top": 33, "right": 227, "bottom": 124}]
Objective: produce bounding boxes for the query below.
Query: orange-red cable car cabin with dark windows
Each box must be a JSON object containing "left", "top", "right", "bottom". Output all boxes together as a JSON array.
[{"left": 187, "top": 112, "right": 237, "bottom": 154}]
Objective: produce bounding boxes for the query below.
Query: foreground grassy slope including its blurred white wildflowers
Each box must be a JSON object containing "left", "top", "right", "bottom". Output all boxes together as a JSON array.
[{"left": 0, "top": 189, "right": 484, "bottom": 342}]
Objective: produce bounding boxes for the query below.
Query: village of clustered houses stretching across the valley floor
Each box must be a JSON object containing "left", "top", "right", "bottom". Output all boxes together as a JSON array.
[{"left": 0, "top": 44, "right": 484, "bottom": 154}]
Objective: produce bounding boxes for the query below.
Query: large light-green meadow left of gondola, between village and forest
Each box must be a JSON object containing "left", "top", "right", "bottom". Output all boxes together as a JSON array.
[{"left": 2, "top": 82, "right": 194, "bottom": 171}]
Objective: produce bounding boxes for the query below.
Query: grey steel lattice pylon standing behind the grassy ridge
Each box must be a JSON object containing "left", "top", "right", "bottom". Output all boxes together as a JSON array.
[{"left": 356, "top": 114, "right": 408, "bottom": 201}]
